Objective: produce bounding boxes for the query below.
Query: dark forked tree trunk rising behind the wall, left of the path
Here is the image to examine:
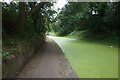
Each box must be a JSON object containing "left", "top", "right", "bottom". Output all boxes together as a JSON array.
[{"left": 15, "top": 2, "right": 44, "bottom": 33}]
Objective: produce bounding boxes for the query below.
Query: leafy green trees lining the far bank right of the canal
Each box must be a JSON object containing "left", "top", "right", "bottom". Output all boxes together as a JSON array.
[{"left": 53, "top": 2, "right": 120, "bottom": 41}]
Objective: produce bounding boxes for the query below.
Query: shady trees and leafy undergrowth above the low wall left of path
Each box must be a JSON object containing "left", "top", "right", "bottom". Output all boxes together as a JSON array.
[{"left": 2, "top": 2, "right": 55, "bottom": 60}]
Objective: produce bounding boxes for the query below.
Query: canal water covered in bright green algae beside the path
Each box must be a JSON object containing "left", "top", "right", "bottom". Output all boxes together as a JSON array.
[{"left": 48, "top": 36, "right": 118, "bottom": 78}]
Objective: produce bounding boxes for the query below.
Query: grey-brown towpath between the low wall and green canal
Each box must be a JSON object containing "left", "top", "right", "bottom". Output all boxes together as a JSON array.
[{"left": 17, "top": 38, "right": 77, "bottom": 78}]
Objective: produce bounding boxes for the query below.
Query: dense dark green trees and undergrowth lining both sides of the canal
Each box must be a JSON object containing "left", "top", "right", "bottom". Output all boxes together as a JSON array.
[{"left": 2, "top": 2, "right": 120, "bottom": 59}]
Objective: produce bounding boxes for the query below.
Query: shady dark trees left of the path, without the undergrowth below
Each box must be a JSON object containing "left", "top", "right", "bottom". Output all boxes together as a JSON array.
[{"left": 3, "top": 2, "right": 55, "bottom": 36}]
